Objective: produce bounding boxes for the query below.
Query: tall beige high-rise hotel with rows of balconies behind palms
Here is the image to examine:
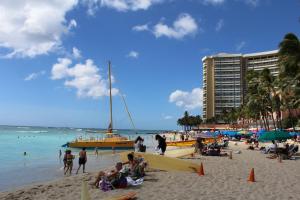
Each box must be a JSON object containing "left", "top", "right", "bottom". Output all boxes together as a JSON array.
[{"left": 202, "top": 50, "right": 279, "bottom": 120}]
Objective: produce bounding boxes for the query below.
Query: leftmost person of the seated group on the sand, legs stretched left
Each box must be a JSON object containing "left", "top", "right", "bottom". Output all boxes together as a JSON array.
[{"left": 93, "top": 162, "right": 127, "bottom": 189}]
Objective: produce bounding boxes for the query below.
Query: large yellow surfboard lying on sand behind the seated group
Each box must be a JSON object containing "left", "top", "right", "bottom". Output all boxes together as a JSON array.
[{"left": 120, "top": 152, "right": 199, "bottom": 172}]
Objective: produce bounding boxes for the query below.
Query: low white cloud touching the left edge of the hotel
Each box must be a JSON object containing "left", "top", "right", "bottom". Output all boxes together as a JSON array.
[{"left": 169, "top": 88, "right": 203, "bottom": 110}]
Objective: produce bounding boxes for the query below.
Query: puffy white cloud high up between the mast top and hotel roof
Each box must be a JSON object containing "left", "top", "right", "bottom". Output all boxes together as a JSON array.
[{"left": 153, "top": 13, "right": 198, "bottom": 39}]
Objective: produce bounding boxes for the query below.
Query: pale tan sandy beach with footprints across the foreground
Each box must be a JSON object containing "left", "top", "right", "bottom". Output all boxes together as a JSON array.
[{"left": 0, "top": 143, "right": 300, "bottom": 200}]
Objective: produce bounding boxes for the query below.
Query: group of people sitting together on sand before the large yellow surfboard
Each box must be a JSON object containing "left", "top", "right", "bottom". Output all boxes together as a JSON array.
[{"left": 94, "top": 153, "right": 147, "bottom": 191}]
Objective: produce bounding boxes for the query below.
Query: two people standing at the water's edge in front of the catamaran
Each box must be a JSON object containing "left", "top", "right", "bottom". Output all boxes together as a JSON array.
[{"left": 59, "top": 148, "right": 87, "bottom": 175}]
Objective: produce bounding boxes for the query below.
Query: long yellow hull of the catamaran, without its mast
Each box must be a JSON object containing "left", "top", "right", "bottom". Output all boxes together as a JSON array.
[{"left": 68, "top": 141, "right": 134, "bottom": 150}]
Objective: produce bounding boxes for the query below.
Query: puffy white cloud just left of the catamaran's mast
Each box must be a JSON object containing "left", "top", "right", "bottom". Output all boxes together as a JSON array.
[{"left": 51, "top": 58, "right": 119, "bottom": 98}]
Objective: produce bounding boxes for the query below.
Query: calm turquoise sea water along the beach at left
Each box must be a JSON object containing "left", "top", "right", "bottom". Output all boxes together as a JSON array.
[{"left": 0, "top": 126, "right": 159, "bottom": 191}]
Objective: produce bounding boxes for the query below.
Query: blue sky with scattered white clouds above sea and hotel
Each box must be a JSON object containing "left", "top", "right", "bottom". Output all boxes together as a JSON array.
[{"left": 0, "top": 0, "right": 300, "bottom": 129}]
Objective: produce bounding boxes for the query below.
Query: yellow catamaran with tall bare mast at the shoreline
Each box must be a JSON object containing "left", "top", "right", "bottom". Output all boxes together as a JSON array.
[{"left": 67, "top": 62, "right": 134, "bottom": 149}]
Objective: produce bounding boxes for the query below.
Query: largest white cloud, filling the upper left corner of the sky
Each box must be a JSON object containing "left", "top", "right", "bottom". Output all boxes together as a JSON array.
[{"left": 0, "top": 0, "right": 78, "bottom": 58}]
